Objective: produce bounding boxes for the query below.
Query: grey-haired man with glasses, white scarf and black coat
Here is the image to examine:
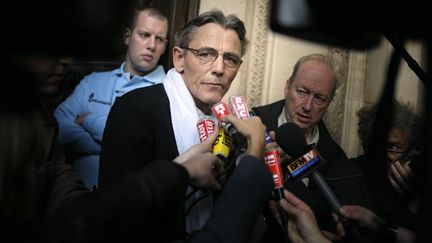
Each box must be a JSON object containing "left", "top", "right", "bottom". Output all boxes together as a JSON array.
[{"left": 99, "top": 10, "right": 248, "bottom": 242}]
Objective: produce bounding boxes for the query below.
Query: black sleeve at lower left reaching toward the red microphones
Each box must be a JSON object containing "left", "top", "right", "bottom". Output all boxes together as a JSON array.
[{"left": 44, "top": 161, "right": 189, "bottom": 242}]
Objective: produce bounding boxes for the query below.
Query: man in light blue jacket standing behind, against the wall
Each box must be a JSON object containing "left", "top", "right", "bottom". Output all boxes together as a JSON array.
[{"left": 54, "top": 6, "right": 168, "bottom": 188}]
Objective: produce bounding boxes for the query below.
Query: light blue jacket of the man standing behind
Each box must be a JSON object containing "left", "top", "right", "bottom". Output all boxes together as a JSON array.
[{"left": 54, "top": 63, "right": 165, "bottom": 187}]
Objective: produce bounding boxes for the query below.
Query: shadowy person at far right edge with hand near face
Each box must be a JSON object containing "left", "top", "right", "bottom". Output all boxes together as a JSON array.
[{"left": 334, "top": 100, "right": 426, "bottom": 242}]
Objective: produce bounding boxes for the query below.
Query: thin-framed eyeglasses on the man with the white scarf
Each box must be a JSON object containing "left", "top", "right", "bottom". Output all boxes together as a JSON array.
[{"left": 180, "top": 47, "right": 243, "bottom": 68}]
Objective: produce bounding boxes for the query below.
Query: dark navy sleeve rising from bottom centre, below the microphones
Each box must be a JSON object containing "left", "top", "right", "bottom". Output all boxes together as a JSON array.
[{"left": 189, "top": 156, "right": 274, "bottom": 243}]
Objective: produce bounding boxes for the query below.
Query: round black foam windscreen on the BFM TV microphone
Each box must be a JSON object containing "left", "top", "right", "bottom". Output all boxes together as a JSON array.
[{"left": 276, "top": 122, "right": 308, "bottom": 156}]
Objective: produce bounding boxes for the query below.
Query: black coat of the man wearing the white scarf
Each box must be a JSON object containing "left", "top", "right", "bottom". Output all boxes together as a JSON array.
[{"left": 99, "top": 84, "right": 184, "bottom": 242}]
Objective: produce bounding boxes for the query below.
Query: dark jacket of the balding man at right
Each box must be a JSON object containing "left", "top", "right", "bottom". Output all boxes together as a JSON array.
[{"left": 252, "top": 100, "right": 347, "bottom": 239}]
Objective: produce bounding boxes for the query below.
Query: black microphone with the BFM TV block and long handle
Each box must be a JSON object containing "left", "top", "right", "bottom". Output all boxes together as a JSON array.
[{"left": 276, "top": 122, "right": 363, "bottom": 242}]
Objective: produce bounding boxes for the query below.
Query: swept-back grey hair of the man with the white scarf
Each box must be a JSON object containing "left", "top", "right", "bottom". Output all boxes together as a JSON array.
[{"left": 175, "top": 10, "right": 248, "bottom": 56}]
